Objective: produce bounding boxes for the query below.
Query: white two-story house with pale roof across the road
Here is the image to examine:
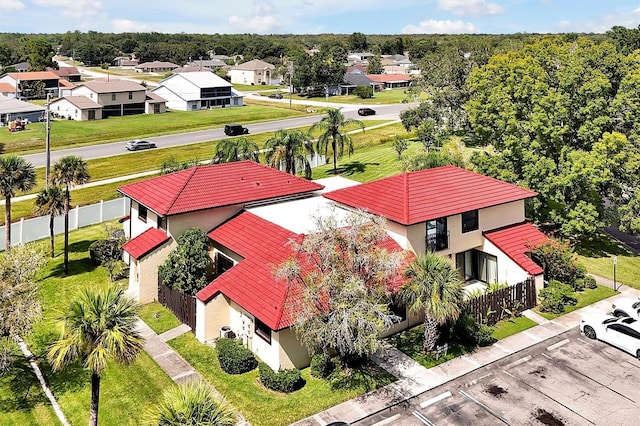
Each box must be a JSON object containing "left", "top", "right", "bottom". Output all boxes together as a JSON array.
[{"left": 152, "top": 71, "right": 243, "bottom": 111}]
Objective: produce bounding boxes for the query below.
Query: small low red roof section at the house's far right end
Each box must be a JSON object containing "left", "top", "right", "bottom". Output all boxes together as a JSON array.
[{"left": 484, "top": 223, "right": 548, "bottom": 275}]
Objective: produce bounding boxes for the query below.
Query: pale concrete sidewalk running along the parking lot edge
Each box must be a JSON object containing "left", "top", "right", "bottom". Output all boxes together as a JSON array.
[{"left": 294, "top": 277, "right": 640, "bottom": 426}]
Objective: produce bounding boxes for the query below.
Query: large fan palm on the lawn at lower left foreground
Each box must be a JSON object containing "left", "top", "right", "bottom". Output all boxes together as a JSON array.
[{"left": 47, "top": 287, "right": 144, "bottom": 426}]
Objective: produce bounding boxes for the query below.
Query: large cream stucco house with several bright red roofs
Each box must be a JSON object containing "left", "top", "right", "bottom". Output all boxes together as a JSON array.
[{"left": 119, "top": 161, "right": 546, "bottom": 370}]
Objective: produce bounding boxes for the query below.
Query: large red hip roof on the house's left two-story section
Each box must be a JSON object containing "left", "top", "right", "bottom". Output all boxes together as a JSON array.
[{"left": 118, "top": 161, "right": 324, "bottom": 216}]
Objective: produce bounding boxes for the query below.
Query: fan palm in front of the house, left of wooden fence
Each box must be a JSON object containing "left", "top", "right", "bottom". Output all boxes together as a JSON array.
[{"left": 399, "top": 252, "right": 463, "bottom": 353}]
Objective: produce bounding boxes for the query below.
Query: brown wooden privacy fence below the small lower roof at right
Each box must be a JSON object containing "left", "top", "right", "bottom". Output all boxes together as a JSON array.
[{"left": 466, "top": 278, "right": 537, "bottom": 326}]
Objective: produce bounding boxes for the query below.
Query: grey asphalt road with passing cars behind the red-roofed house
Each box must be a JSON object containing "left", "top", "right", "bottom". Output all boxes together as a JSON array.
[{"left": 24, "top": 103, "right": 415, "bottom": 167}]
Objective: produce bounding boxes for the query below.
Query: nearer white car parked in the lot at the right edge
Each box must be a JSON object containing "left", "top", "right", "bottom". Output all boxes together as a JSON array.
[{"left": 580, "top": 315, "right": 640, "bottom": 359}]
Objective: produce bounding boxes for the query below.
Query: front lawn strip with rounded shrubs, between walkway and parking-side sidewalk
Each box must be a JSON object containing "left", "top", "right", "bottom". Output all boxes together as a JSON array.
[{"left": 168, "top": 333, "right": 395, "bottom": 426}]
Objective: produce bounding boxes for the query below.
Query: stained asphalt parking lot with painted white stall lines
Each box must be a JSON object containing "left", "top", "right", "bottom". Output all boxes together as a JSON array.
[{"left": 354, "top": 327, "right": 640, "bottom": 426}]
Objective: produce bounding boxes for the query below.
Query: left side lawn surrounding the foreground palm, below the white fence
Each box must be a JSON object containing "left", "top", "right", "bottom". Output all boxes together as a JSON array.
[{"left": 0, "top": 225, "right": 173, "bottom": 426}]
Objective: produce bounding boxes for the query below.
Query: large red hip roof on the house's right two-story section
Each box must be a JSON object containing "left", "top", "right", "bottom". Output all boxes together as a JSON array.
[{"left": 323, "top": 166, "right": 537, "bottom": 225}]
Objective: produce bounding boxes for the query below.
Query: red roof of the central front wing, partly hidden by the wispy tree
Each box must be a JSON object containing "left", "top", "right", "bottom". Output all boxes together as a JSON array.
[{"left": 196, "top": 211, "right": 412, "bottom": 330}]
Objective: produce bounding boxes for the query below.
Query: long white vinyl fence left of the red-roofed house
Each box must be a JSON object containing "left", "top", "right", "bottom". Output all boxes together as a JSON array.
[{"left": 0, "top": 197, "right": 130, "bottom": 250}]
